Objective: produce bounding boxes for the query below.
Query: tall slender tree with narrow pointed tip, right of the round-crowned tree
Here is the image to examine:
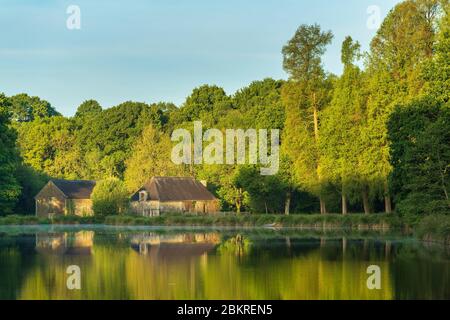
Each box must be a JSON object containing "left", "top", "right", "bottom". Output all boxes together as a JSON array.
[{"left": 320, "top": 37, "right": 370, "bottom": 214}]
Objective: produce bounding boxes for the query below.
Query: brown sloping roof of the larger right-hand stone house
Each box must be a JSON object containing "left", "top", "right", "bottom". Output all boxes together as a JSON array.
[{"left": 131, "top": 177, "right": 217, "bottom": 202}]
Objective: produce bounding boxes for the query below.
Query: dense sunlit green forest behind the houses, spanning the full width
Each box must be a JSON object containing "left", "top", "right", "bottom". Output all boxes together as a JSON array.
[{"left": 0, "top": 0, "right": 450, "bottom": 215}]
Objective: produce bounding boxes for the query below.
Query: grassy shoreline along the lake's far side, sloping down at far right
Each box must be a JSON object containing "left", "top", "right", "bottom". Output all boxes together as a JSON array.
[{"left": 0, "top": 214, "right": 450, "bottom": 246}]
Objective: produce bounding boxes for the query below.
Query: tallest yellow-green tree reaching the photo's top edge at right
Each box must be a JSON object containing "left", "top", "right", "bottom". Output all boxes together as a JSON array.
[{"left": 362, "top": 0, "right": 440, "bottom": 212}]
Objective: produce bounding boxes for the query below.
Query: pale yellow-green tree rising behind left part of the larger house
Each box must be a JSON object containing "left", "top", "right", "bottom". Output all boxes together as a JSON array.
[{"left": 125, "top": 125, "right": 184, "bottom": 192}]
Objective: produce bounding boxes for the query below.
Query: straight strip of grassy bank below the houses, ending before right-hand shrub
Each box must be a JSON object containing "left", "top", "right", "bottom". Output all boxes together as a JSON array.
[{"left": 0, "top": 214, "right": 404, "bottom": 230}]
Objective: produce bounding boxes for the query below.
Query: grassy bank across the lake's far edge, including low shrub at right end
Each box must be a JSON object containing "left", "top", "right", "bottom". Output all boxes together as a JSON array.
[{"left": 0, "top": 214, "right": 450, "bottom": 245}]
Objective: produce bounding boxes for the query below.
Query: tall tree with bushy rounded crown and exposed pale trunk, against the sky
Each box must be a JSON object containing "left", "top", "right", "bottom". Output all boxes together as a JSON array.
[{"left": 282, "top": 25, "right": 333, "bottom": 214}]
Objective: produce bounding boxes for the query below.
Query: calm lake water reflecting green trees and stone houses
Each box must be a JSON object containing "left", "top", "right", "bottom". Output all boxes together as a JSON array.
[{"left": 0, "top": 226, "right": 450, "bottom": 300}]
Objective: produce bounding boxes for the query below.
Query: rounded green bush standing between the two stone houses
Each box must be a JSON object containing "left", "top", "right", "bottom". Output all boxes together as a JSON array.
[{"left": 92, "top": 178, "right": 129, "bottom": 217}]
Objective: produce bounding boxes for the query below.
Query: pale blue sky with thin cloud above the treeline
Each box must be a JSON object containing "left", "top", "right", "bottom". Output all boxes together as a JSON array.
[{"left": 0, "top": 0, "right": 399, "bottom": 116}]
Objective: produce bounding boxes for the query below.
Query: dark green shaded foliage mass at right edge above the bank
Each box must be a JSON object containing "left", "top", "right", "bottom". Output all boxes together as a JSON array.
[{"left": 388, "top": 98, "right": 450, "bottom": 216}]
